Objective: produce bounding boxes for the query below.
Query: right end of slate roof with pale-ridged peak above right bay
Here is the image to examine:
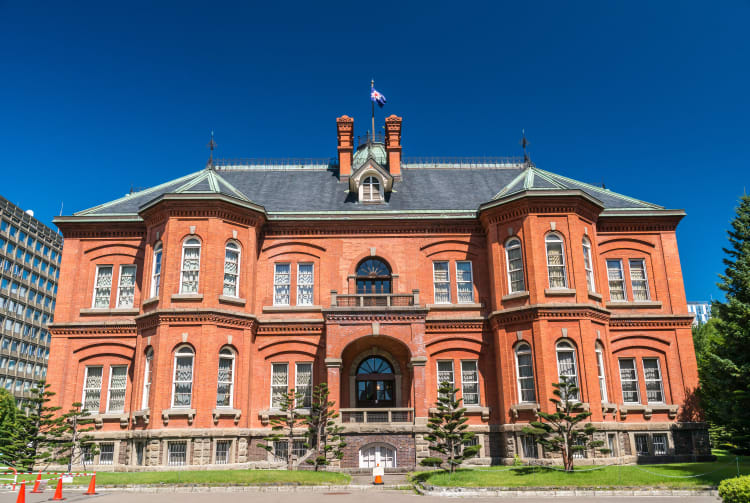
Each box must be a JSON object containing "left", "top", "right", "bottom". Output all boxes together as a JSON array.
[{"left": 492, "top": 164, "right": 664, "bottom": 209}]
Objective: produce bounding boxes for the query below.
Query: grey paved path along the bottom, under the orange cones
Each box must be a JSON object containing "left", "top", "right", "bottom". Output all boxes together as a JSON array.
[{"left": 0, "top": 488, "right": 720, "bottom": 503}]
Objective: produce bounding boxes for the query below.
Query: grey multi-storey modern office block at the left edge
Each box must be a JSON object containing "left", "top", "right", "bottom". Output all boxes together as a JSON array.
[{"left": 0, "top": 196, "right": 62, "bottom": 403}]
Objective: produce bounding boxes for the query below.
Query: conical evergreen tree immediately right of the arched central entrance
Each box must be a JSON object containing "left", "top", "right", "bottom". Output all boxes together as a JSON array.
[{"left": 420, "top": 382, "right": 479, "bottom": 473}]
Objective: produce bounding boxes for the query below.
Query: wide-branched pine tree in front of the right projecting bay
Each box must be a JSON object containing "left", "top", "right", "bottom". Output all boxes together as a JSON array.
[{"left": 523, "top": 376, "right": 609, "bottom": 471}]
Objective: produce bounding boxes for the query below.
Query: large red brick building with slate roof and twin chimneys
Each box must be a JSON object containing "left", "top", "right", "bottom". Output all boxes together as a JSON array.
[{"left": 49, "top": 116, "right": 708, "bottom": 469}]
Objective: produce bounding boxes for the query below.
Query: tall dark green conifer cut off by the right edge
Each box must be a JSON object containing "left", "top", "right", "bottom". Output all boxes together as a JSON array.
[{"left": 700, "top": 195, "right": 750, "bottom": 450}]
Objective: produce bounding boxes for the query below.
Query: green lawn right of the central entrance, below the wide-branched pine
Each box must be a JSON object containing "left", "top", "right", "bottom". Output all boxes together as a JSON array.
[{"left": 411, "top": 450, "right": 750, "bottom": 488}]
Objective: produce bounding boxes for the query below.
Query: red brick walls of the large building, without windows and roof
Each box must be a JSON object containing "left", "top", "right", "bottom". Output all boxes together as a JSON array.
[{"left": 48, "top": 114, "right": 708, "bottom": 469}]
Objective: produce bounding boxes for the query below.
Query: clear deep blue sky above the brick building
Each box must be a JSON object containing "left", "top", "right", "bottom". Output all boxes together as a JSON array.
[{"left": 0, "top": 0, "right": 750, "bottom": 300}]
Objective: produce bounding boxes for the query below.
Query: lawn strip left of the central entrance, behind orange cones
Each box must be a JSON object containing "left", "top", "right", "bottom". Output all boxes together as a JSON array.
[{"left": 23, "top": 469, "right": 351, "bottom": 487}]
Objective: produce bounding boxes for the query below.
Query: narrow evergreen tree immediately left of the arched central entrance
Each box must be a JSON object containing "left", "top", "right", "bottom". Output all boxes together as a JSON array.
[{"left": 305, "top": 383, "right": 346, "bottom": 471}]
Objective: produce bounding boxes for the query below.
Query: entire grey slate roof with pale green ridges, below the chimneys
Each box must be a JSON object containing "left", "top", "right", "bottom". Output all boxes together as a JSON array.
[{"left": 75, "top": 164, "right": 663, "bottom": 216}]
